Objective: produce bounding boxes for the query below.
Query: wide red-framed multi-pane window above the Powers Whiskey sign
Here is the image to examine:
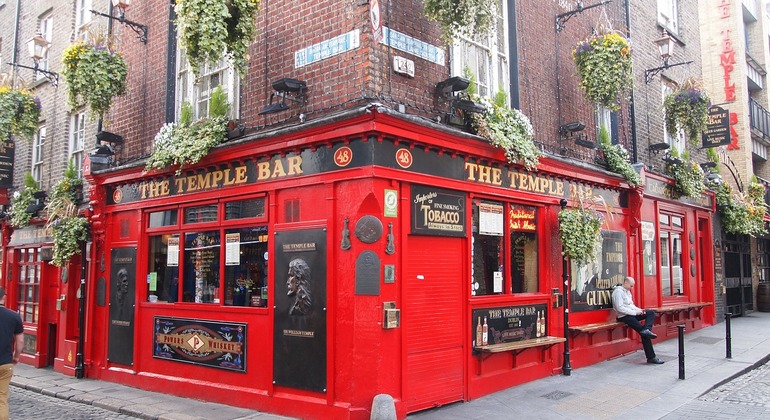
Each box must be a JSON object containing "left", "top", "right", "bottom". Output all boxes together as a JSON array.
[{"left": 147, "top": 197, "right": 269, "bottom": 307}]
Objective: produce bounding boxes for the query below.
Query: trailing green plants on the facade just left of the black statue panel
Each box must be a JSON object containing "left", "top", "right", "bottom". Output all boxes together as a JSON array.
[{"left": 46, "top": 159, "right": 88, "bottom": 267}]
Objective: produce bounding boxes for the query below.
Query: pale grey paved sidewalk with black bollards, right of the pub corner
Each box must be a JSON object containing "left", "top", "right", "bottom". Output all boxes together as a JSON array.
[{"left": 409, "top": 312, "right": 770, "bottom": 420}]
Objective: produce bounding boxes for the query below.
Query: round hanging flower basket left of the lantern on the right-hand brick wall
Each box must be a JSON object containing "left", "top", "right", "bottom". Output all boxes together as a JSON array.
[{"left": 572, "top": 32, "right": 633, "bottom": 111}]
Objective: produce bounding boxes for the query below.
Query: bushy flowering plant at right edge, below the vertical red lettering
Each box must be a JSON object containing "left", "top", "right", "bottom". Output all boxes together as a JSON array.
[{"left": 716, "top": 178, "right": 767, "bottom": 237}]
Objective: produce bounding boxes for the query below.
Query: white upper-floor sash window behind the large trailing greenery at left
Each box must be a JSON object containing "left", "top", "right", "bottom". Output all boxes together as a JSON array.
[{"left": 176, "top": 50, "right": 238, "bottom": 120}]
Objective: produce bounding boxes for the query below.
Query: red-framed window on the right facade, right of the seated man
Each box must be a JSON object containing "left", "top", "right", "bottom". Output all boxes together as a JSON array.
[{"left": 658, "top": 213, "right": 684, "bottom": 297}]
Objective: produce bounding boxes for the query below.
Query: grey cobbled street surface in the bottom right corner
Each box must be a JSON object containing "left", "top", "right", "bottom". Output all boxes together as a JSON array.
[{"left": 664, "top": 363, "right": 770, "bottom": 420}]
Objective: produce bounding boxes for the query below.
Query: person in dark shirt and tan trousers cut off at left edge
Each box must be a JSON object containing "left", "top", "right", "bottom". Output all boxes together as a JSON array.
[{"left": 0, "top": 287, "right": 24, "bottom": 420}]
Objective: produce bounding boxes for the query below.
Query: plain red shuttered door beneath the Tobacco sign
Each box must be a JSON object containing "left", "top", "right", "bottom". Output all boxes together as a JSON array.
[{"left": 403, "top": 236, "right": 462, "bottom": 412}]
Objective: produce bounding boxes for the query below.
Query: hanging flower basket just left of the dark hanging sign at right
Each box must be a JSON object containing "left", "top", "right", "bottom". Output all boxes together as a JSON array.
[{"left": 663, "top": 79, "right": 710, "bottom": 143}]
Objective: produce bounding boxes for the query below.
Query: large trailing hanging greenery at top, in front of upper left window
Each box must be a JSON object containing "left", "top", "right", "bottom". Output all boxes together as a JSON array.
[{"left": 174, "top": 0, "right": 259, "bottom": 76}]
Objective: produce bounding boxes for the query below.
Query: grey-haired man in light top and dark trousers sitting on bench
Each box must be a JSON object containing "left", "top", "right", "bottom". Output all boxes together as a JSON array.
[{"left": 612, "top": 277, "right": 663, "bottom": 365}]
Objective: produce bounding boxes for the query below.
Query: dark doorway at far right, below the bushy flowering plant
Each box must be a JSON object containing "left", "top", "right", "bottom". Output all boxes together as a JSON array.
[{"left": 722, "top": 234, "right": 754, "bottom": 316}]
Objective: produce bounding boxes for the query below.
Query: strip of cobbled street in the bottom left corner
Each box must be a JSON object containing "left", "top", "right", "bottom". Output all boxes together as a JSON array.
[{"left": 8, "top": 387, "right": 135, "bottom": 420}]
